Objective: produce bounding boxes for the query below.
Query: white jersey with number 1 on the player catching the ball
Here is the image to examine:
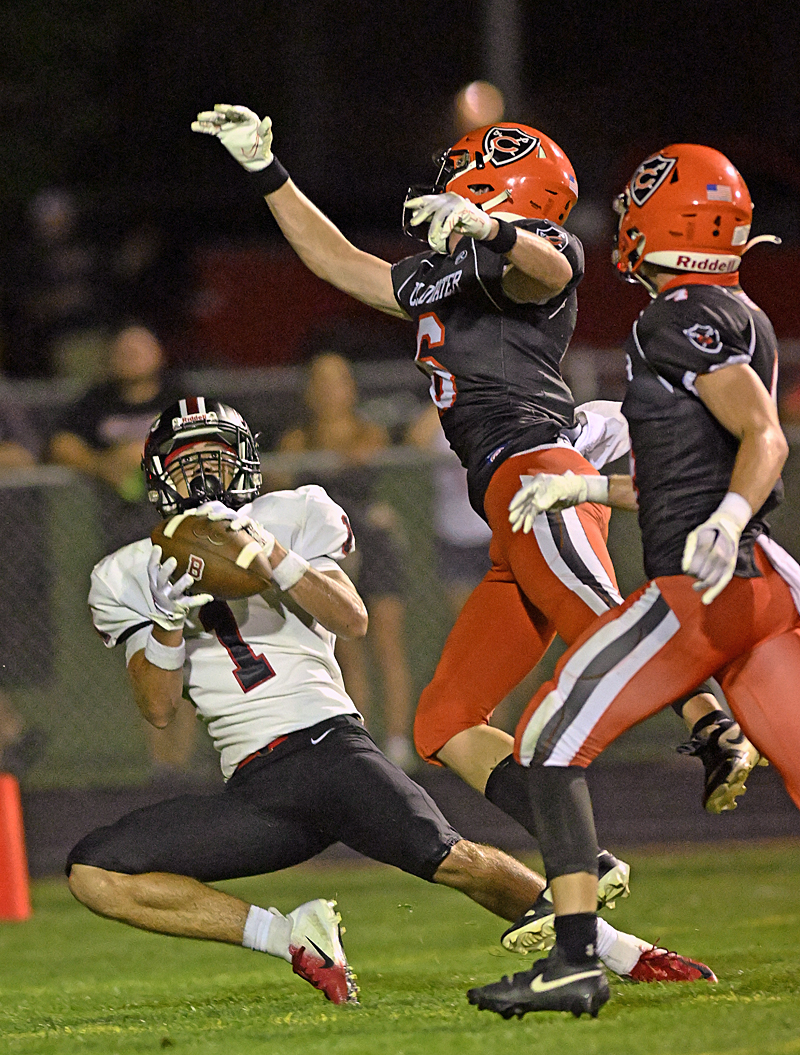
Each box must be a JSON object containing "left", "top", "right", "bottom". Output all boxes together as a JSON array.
[{"left": 89, "top": 484, "right": 357, "bottom": 779}]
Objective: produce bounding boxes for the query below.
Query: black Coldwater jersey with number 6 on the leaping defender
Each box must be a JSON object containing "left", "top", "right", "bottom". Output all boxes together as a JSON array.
[{"left": 392, "top": 219, "right": 584, "bottom": 516}]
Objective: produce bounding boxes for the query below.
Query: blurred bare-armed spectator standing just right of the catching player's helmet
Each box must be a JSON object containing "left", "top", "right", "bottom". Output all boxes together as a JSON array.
[{"left": 279, "top": 352, "right": 416, "bottom": 767}]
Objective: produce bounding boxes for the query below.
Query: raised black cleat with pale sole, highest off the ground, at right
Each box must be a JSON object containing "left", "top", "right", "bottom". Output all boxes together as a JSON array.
[{"left": 678, "top": 714, "right": 768, "bottom": 813}]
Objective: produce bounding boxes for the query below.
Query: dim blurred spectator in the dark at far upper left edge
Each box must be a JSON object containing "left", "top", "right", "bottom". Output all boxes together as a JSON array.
[{"left": 5, "top": 188, "right": 108, "bottom": 378}]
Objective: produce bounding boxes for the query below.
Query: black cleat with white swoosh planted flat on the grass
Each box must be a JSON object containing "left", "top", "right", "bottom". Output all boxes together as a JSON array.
[{"left": 466, "top": 950, "right": 610, "bottom": 1018}]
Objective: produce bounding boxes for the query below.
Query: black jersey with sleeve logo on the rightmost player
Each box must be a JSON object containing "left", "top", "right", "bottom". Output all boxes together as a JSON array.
[{"left": 623, "top": 284, "right": 782, "bottom": 578}]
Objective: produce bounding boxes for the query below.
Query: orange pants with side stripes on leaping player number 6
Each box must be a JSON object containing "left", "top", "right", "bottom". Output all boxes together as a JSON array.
[{"left": 414, "top": 445, "right": 622, "bottom": 762}]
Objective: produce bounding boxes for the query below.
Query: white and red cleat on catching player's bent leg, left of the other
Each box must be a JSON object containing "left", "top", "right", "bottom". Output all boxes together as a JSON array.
[{"left": 286, "top": 898, "right": 359, "bottom": 1004}]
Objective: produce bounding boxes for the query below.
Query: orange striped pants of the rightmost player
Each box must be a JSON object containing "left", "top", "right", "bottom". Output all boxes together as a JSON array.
[{"left": 515, "top": 545, "right": 800, "bottom": 807}]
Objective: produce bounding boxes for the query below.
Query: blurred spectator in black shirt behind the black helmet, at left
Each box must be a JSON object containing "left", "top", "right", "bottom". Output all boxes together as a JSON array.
[{"left": 47, "top": 323, "right": 196, "bottom": 787}]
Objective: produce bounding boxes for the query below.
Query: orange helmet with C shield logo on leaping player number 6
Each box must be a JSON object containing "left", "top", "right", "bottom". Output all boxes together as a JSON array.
[{"left": 403, "top": 121, "right": 577, "bottom": 241}]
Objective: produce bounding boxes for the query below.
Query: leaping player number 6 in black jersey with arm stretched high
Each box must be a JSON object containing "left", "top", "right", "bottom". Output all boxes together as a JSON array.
[{"left": 192, "top": 103, "right": 757, "bottom": 977}]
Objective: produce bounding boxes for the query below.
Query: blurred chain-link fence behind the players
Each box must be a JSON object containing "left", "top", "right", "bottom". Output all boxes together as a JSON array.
[{"left": 0, "top": 367, "right": 800, "bottom": 788}]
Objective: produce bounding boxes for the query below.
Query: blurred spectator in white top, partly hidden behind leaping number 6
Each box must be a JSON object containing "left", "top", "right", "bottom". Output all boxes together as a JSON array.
[{"left": 406, "top": 403, "right": 492, "bottom": 622}]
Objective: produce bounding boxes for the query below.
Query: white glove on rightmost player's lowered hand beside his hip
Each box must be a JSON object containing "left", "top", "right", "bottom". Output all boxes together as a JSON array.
[{"left": 681, "top": 491, "right": 753, "bottom": 605}]
